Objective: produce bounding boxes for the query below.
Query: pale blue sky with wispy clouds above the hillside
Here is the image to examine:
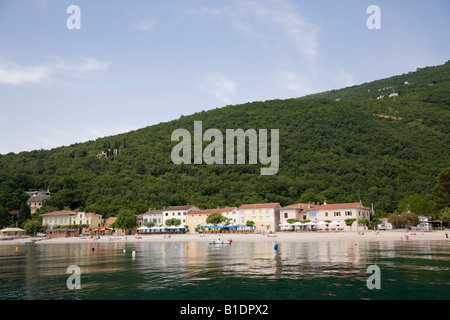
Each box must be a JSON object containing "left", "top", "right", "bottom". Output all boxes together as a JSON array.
[{"left": 0, "top": 0, "right": 450, "bottom": 154}]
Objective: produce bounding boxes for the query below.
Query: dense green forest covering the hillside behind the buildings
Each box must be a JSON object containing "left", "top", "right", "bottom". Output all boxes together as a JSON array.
[{"left": 0, "top": 62, "right": 450, "bottom": 222}]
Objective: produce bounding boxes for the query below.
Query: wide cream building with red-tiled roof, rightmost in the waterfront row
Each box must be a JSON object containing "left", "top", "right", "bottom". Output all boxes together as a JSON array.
[{"left": 307, "top": 201, "right": 370, "bottom": 231}]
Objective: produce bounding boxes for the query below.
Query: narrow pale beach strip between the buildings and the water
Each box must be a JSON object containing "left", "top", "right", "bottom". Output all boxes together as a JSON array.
[{"left": 0, "top": 230, "right": 450, "bottom": 246}]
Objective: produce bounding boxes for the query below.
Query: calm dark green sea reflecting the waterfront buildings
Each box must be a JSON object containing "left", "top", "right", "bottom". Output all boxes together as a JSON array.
[{"left": 0, "top": 241, "right": 450, "bottom": 300}]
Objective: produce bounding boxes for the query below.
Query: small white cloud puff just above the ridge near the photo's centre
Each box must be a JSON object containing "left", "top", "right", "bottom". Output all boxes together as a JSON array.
[{"left": 199, "top": 73, "right": 237, "bottom": 104}]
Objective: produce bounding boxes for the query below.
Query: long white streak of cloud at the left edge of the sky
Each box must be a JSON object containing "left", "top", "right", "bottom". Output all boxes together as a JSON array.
[{"left": 0, "top": 58, "right": 111, "bottom": 85}]
